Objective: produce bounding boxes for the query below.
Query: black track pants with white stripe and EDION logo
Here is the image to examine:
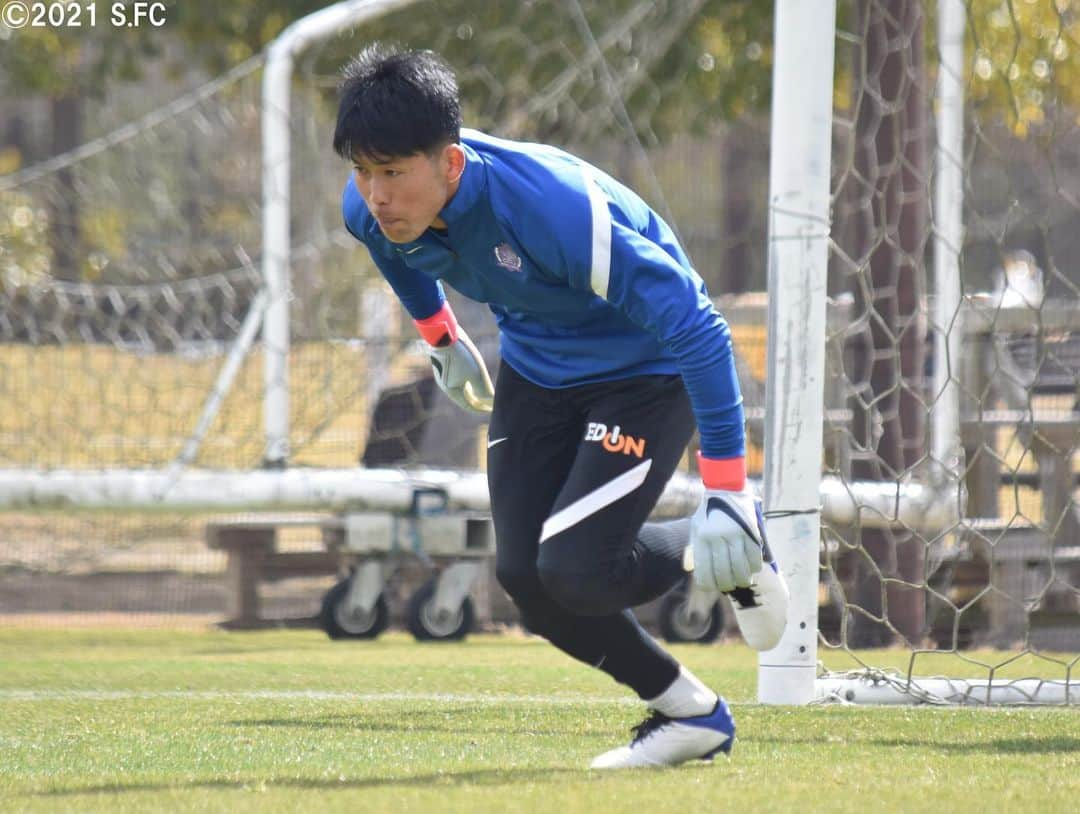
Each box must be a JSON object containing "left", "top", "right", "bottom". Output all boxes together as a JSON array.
[{"left": 487, "top": 363, "right": 694, "bottom": 698}]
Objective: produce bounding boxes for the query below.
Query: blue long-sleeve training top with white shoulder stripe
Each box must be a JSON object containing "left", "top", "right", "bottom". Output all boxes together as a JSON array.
[{"left": 341, "top": 130, "right": 745, "bottom": 458}]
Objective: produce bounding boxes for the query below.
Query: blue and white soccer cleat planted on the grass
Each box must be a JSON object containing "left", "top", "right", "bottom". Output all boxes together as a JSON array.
[{"left": 590, "top": 698, "right": 735, "bottom": 769}]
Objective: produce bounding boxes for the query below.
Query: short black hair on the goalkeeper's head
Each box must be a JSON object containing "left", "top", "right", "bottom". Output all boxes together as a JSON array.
[{"left": 334, "top": 43, "right": 461, "bottom": 161}]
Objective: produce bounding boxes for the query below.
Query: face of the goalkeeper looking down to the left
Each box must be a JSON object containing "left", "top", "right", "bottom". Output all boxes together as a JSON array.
[{"left": 353, "top": 145, "right": 464, "bottom": 243}]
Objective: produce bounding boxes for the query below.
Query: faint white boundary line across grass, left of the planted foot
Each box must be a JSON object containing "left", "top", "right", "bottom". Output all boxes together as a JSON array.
[{"left": 0, "top": 689, "right": 642, "bottom": 706}]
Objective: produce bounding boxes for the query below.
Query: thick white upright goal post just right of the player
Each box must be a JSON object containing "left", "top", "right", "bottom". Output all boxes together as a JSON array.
[{"left": 758, "top": 0, "right": 836, "bottom": 704}]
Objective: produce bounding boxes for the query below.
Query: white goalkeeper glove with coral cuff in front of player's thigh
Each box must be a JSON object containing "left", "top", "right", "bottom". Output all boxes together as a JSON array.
[{"left": 415, "top": 302, "right": 495, "bottom": 412}]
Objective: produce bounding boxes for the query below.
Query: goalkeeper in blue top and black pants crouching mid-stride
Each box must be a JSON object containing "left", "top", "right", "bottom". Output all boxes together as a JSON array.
[{"left": 334, "top": 45, "right": 787, "bottom": 769}]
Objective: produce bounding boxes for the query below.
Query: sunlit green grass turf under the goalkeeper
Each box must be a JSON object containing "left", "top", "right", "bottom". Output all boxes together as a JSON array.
[{"left": 0, "top": 630, "right": 1080, "bottom": 814}]
